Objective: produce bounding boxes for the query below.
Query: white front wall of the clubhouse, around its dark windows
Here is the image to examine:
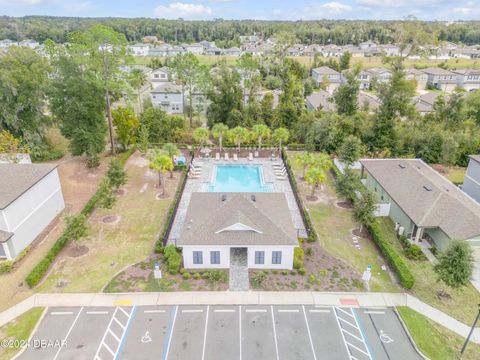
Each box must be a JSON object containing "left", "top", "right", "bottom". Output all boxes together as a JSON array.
[{"left": 182, "top": 245, "right": 294, "bottom": 269}]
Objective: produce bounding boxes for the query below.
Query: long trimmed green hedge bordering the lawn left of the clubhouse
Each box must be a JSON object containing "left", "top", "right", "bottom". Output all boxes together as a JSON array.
[{"left": 25, "top": 148, "right": 135, "bottom": 288}]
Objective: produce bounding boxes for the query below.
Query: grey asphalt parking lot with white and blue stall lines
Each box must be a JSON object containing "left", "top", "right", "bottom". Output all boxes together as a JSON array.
[{"left": 19, "top": 305, "right": 421, "bottom": 360}]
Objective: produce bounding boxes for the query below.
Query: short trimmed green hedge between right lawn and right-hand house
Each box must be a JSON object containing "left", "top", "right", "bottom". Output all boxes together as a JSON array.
[{"left": 367, "top": 221, "right": 415, "bottom": 289}]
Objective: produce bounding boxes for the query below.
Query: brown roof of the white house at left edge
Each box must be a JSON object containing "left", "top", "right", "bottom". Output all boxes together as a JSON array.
[{"left": 0, "top": 164, "right": 57, "bottom": 209}]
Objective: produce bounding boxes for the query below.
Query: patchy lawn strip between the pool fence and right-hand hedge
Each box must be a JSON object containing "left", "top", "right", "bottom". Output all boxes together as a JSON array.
[{"left": 288, "top": 151, "right": 400, "bottom": 292}]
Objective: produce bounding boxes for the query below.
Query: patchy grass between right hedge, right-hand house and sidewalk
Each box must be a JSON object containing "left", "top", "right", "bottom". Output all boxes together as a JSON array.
[{"left": 378, "top": 218, "right": 480, "bottom": 324}]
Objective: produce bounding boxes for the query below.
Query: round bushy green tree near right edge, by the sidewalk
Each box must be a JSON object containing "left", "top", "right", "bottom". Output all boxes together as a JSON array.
[{"left": 435, "top": 240, "right": 473, "bottom": 288}]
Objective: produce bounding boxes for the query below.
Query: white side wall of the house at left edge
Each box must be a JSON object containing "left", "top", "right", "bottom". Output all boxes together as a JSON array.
[{"left": 0, "top": 169, "right": 65, "bottom": 258}]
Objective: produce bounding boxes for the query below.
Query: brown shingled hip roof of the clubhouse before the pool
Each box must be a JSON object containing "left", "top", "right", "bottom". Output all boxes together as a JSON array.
[{"left": 177, "top": 192, "right": 298, "bottom": 246}]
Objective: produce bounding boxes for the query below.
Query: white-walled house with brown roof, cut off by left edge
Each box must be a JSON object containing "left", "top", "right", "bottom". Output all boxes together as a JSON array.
[{"left": 0, "top": 164, "right": 65, "bottom": 260}]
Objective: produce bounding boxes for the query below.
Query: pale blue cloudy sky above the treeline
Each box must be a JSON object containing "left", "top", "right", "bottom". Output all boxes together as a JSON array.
[{"left": 0, "top": 0, "right": 480, "bottom": 20}]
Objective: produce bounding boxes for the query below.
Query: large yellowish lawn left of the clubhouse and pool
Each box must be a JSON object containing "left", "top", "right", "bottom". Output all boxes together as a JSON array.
[{"left": 38, "top": 153, "right": 180, "bottom": 292}]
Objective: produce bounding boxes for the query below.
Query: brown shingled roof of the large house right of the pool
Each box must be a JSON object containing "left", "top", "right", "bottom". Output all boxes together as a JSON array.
[{"left": 361, "top": 159, "right": 480, "bottom": 240}]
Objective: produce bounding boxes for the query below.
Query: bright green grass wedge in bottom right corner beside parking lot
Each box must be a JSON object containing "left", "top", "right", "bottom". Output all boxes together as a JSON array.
[{"left": 397, "top": 307, "right": 480, "bottom": 360}]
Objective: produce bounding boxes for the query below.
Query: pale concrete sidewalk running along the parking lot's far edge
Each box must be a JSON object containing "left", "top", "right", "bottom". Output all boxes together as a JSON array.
[{"left": 0, "top": 291, "right": 480, "bottom": 344}]
